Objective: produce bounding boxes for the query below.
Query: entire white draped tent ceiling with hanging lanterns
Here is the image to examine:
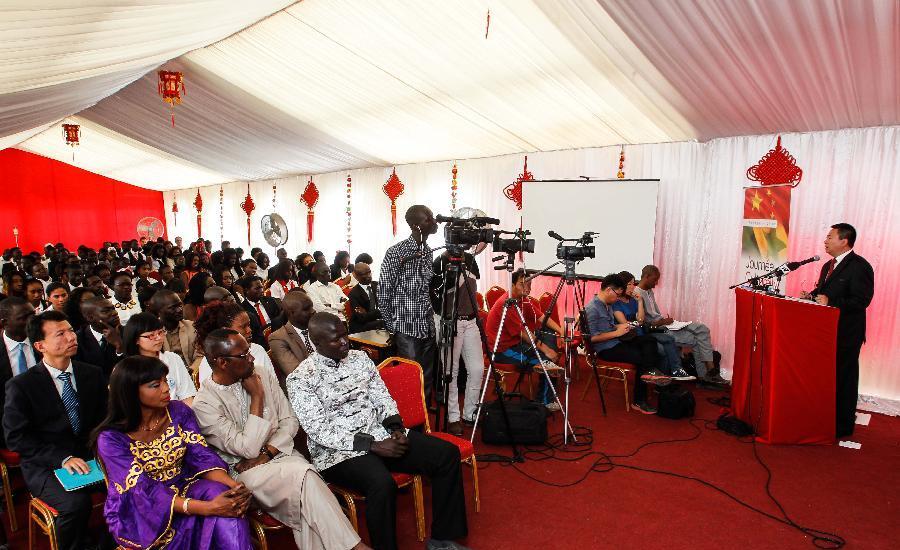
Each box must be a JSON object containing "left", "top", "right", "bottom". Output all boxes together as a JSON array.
[{"left": 0, "top": 0, "right": 900, "bottom": 189}]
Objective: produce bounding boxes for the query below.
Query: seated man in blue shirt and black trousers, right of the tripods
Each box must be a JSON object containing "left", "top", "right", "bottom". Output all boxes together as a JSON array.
[{"left": 584, "top": 273, "right": 671, "bottom": 414}]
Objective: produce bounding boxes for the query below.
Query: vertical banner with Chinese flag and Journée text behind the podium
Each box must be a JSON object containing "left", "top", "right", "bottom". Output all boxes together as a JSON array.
[{"left": 741, "top": 185, "right": 791, "bottom": 290}]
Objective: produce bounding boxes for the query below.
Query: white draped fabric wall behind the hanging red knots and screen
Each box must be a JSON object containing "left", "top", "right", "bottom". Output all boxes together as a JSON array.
[{"left": 165, "top": 127, "right": 900, "bottom": 399}]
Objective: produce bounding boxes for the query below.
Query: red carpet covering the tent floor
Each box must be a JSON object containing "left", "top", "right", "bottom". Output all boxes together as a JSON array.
[{"left": 4, "top": 372, "right": 900, "bottom": 550}]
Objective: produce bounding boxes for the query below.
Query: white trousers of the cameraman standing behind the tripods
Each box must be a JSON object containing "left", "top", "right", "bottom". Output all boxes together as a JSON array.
[{"left": 447, "top": 319, "right": 484, "bottom": 422}]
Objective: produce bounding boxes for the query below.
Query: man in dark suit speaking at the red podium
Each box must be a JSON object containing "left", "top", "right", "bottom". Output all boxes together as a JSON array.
[{"left": 805, "top": 223, "right": 875, "bottom": 438}]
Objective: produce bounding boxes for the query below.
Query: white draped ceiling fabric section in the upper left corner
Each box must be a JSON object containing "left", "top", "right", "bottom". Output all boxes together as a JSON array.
[{"left": 0, "top": 0, "right": 292, "bottom": 144}]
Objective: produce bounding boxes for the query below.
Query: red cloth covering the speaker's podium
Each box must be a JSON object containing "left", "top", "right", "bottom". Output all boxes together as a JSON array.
[{"left": 731, "top": 288, "right": 839, "bottom": 444}]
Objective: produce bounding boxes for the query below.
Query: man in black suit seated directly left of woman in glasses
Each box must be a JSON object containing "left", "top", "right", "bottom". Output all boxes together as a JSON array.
[{"left": 75, "top": 298, "right": 125, "bottom": 378}]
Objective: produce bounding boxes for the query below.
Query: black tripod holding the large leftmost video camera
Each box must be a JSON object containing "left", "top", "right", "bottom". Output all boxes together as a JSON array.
[{"left": 436, "top": 252, "right": 525, "bottom": 462}]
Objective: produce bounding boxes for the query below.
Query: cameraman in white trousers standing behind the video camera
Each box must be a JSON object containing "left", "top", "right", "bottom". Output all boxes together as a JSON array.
[{"left": 431, "top": 250, "right": 484, "bottom": 436}]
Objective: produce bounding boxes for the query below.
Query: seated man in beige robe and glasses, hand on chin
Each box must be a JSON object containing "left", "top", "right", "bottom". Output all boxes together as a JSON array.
[{"left": 194, "top": 329, "right": 367, "bottom": 549}]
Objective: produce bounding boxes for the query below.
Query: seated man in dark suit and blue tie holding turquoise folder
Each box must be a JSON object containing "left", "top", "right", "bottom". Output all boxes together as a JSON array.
[{"left": 3, "top": 311, "right": 106, "bottom": 550}]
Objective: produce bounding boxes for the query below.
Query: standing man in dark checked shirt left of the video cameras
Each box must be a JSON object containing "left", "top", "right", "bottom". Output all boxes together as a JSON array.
[{"left": 378, "top": 204, "right": 437, "bottom": 408}]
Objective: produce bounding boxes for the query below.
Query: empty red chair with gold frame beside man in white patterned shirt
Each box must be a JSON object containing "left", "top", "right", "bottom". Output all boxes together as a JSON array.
[{"left": 378, "top": 357, "right": 481, "bottom": 512}]
